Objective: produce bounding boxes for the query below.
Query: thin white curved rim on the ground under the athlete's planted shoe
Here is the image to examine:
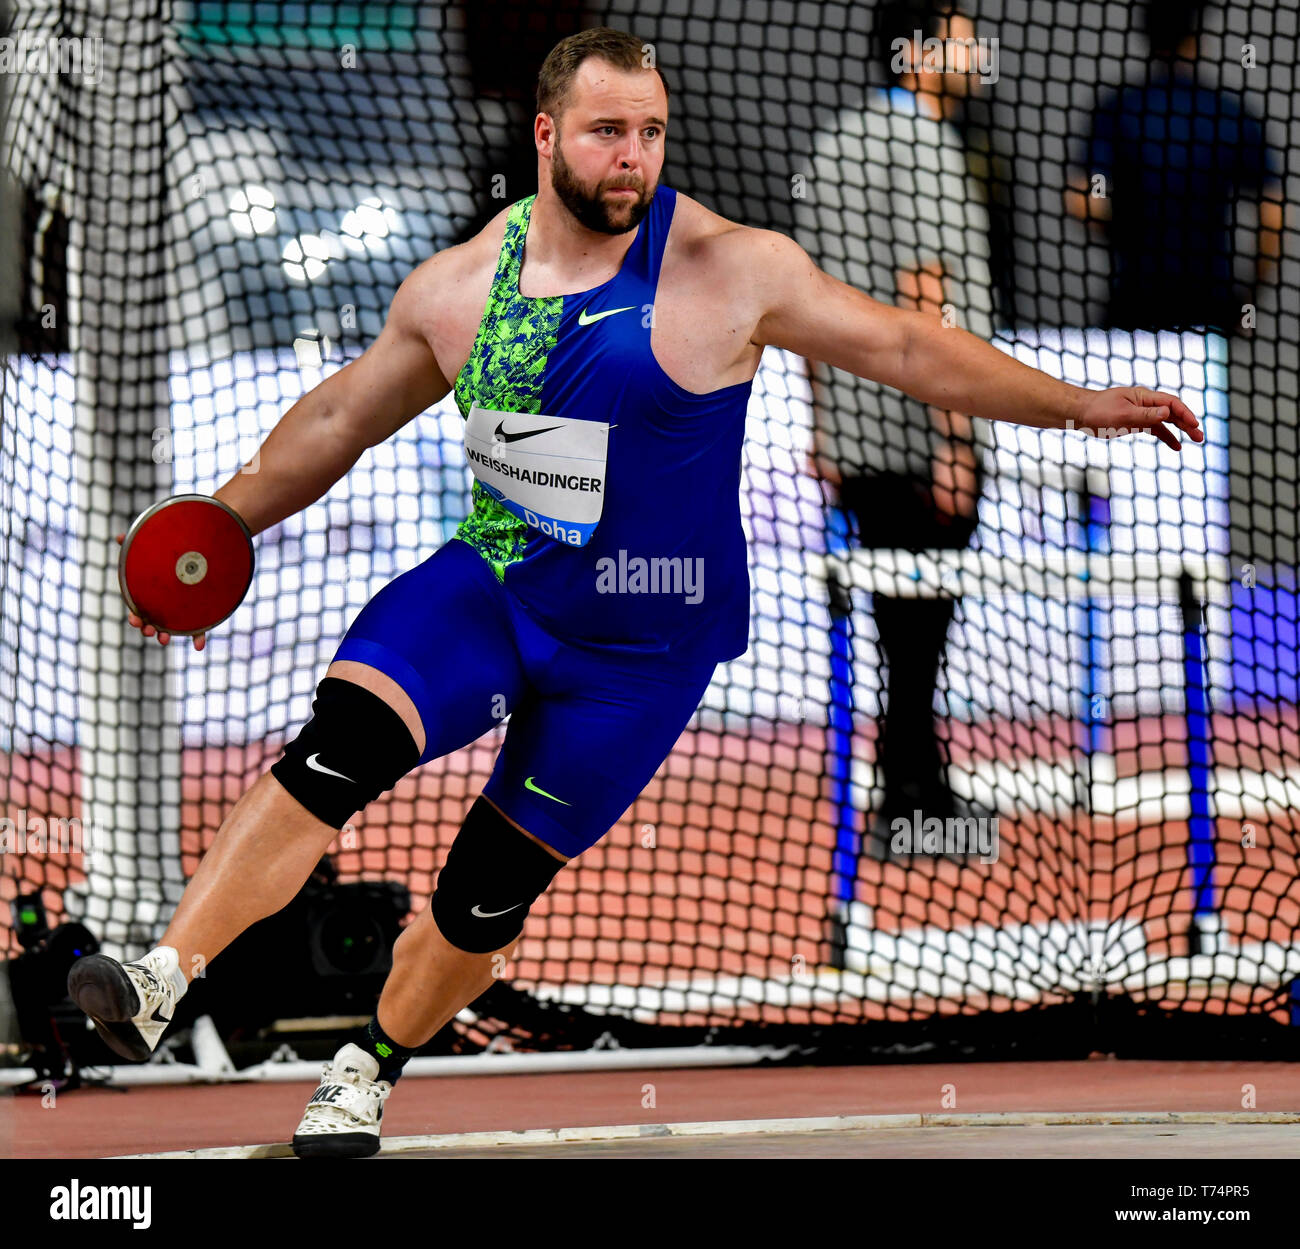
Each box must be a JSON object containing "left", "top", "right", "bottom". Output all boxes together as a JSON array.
[{"left": 117, "top": 1110, "right": 1300, "bottom": 1159}]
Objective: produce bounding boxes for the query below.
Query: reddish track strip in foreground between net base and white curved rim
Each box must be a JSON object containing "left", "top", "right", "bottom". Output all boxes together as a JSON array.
[{"left": 0, "top": 1059, "right": 1300, "bottom": 1158}]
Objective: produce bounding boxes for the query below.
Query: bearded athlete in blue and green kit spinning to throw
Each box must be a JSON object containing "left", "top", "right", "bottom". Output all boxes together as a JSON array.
[{"left": 61, "top": 29, "right": 1203, "bottom": 1155}]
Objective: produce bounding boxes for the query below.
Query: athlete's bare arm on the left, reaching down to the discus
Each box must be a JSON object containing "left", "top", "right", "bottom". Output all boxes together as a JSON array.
[{"left": 215, "top": 248, "right": 463, "bottom": 534}]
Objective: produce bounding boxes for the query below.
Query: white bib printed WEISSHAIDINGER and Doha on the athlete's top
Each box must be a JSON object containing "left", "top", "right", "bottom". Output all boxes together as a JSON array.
[{"left": 465, "top": 403, "right": 610, "bottom": 546}]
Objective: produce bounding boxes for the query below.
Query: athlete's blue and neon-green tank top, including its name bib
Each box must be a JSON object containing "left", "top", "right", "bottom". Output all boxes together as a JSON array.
[{"left": 455, "top": 186, "right": 753, "bottom": 660}]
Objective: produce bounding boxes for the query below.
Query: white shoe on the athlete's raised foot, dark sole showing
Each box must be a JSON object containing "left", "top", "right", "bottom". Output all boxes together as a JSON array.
[{"left": 68, "top": 945, "right": 190, "bottom": 1062}]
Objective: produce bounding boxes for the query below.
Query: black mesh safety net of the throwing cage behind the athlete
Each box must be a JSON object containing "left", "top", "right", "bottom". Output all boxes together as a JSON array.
[{"left": 0, "top": 0, "right": 1300, "bottom": 1062}]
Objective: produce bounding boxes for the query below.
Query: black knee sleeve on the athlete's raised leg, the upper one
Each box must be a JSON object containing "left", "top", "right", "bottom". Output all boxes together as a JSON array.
[{"left": 270, "top": 677, "right": 420, "bottom": 828}]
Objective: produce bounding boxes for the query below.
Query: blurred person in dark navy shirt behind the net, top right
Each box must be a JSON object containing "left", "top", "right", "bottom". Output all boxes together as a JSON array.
[{"left": 1066, "top": 0, "right": 1283, "bottom": 334}]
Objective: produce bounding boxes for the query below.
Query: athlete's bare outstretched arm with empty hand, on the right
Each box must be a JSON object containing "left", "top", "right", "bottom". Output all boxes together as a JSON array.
[{"left": 744, "top": 230, "right": 1205, "bottom": 451}]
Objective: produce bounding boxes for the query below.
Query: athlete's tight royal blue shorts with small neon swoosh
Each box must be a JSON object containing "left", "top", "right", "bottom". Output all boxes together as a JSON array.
[{"left": 334, "top": 538, "right": 716, "bottom": 858}]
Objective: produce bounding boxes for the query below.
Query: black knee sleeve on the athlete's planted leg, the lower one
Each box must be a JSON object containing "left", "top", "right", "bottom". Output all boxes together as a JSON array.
[{"left": 429, "top": 798, "right": 564, "bottom": 954}]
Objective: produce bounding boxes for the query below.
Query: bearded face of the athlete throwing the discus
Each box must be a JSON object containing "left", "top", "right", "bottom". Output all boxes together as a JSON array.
[{"left": 538, "top": 57, "right": 668, "bottom": 234}]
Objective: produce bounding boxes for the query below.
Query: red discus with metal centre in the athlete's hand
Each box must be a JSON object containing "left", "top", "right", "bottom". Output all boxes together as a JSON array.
[{"left": 117, "top": 494, "right": 252, "bottom": 637}]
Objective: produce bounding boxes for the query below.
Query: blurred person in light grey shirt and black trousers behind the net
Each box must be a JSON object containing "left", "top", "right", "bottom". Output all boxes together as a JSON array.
[{"left": 794, "top": 0, "right": 993, "bottom": 856}]
